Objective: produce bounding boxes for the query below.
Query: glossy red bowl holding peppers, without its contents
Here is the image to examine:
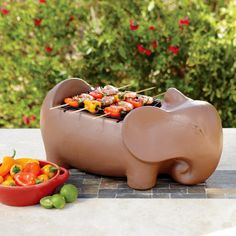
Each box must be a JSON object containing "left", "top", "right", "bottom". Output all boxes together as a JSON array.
[{"left": 0, "top": 160, "right": 69, "bottom": 206}]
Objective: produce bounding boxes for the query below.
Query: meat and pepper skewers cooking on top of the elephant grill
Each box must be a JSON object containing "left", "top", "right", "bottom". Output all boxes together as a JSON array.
[{"left": 52, "top": 85, "right": 161, "bottom": 119}]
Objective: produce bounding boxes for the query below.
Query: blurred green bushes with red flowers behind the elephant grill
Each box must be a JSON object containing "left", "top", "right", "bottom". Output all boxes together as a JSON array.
[{"left": 0, "top": 0, "right": 236, "bottom": 127}]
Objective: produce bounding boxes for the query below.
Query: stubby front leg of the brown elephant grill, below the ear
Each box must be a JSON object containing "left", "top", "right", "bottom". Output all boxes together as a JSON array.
[{"left": 127, "top": 164, "right": 158, "bottom": 190}]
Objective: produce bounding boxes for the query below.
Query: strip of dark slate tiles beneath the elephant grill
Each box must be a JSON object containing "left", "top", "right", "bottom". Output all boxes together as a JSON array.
[{"left": 67, "top": 169, "right": 236, "bottom": 199}]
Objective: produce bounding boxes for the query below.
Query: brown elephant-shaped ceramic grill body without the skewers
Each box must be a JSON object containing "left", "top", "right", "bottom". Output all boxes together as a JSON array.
[{"left": 41, "top": 79, "right": 222, "bottom": 189}]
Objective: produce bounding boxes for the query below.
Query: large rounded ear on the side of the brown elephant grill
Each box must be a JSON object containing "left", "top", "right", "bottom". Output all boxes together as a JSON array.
[{"left": 122, "top": 106, "right": 181, "bottom": 162}]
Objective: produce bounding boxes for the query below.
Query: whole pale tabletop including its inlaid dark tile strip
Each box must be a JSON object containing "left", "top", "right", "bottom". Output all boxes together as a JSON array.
[{"left": 0, "top": 129, "right": 236, "bottom": 236}]
